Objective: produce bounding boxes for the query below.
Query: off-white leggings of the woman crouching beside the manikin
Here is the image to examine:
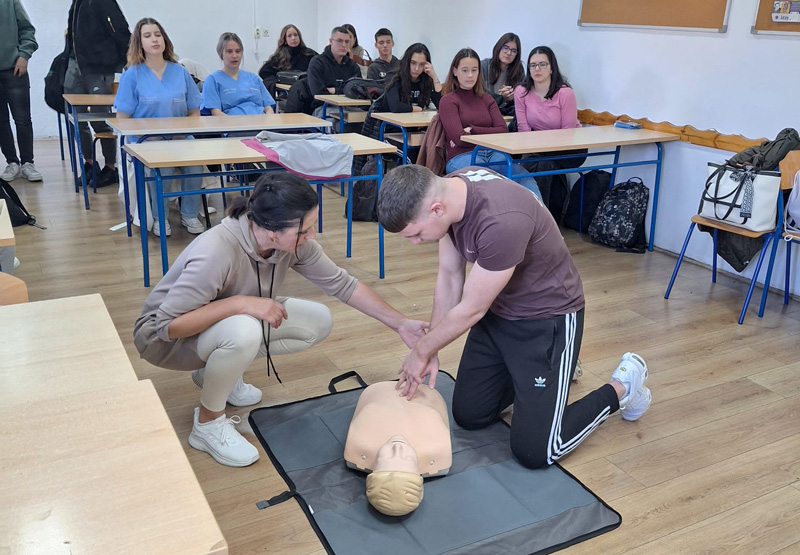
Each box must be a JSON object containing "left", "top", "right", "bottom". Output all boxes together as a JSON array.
[{"left": 197, "top": 298, "right": 333, "bottom": 412}]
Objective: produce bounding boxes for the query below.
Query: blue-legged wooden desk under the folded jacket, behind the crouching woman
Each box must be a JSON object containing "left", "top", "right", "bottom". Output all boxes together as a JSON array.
[{"left": 124, "top": 133, "right": 395, "bottom": 287}]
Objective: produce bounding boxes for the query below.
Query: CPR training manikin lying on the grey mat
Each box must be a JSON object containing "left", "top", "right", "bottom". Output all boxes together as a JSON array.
[{"left": 344, "top": 382, "right": 453, "bottom": 516}]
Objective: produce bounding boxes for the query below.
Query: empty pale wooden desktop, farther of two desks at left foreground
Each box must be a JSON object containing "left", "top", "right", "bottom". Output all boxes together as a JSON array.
[{"left": 0, "top": 294, "right": 137, "bottom": 406}]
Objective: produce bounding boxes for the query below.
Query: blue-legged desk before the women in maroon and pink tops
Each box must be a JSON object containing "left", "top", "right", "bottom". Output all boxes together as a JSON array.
[{"left": 461, "top": 125, "right": 680, "bottom": 251}]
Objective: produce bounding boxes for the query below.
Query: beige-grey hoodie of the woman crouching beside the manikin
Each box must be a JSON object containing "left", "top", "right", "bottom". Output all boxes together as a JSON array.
[{"left": 133, "top": 216, "right": 358, "bottom": 370}]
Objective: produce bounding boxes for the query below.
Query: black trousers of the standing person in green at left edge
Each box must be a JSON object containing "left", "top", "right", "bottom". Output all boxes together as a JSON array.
[{"left": 0, "top": 68, "right": 33, "bottom": 164}]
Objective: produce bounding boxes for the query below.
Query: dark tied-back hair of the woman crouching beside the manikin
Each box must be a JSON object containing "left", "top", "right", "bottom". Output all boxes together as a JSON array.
[{"left": 228, "top": 172, "right": 319, "bottom": 231}]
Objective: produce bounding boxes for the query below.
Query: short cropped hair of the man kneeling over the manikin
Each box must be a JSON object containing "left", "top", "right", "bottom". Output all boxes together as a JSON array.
[{"left": 378, "top": 164, "right": 436, "bottom": 233}]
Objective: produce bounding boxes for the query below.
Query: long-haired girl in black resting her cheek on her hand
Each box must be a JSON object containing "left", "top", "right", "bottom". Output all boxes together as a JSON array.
[{"left": 382, "top": 42, "right": 442, "bottom": 113}]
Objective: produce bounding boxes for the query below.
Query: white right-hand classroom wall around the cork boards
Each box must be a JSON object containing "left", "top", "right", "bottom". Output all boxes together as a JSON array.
[{"left": 318, "top": 0, "right": 800, "bottom": 300}]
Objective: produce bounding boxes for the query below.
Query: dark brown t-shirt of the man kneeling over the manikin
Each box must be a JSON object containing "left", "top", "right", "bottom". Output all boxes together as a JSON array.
[{"left": 447, "top": 167, "right": 585, "bottom": 320}]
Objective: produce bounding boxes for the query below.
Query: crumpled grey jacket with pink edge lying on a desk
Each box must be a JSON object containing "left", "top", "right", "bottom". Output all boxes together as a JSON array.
[{"left": 242, "top": 131, "right": 353, "bottom": 179}]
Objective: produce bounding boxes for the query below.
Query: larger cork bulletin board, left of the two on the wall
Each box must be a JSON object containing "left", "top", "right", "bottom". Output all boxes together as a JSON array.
[{"left": 578, "top": 0, "right": 732, "bottom": 33}]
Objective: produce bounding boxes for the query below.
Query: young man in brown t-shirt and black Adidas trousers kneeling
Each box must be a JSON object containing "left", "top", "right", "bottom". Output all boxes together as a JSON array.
[{"left": 378, "top": 165, "right": 651, "bottom": 468}]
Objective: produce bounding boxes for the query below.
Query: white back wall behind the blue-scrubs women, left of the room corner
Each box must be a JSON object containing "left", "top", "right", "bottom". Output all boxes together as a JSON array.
[{"left": 22, "top": 0, "right": 318, "bottom": 138}]
